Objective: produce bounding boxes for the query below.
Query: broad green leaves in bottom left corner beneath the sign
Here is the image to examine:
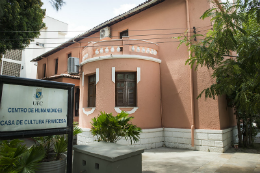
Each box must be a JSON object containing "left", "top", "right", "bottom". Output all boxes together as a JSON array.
[{"left": 0, "top": 139, "right": 45, "bottom": 173}]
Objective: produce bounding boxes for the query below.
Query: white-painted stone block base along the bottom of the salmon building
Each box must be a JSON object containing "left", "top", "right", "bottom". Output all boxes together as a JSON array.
[{"left": 77, "top": 127, "right": 237, "bottom": 152}]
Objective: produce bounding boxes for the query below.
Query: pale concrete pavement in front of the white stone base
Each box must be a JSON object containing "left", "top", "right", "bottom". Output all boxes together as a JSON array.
[{"left": 142, "top": 148, "right": 260, "bottom": 173}]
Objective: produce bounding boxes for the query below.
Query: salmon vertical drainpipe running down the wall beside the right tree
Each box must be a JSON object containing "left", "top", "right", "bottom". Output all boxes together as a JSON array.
[{"left": 186, "top": 0, "right": 195, "bottom": 147}]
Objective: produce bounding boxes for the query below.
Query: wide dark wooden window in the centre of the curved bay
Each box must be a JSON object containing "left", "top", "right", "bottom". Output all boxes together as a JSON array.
[{"left": 116, "top": 73, "right": 136, "bottom": 107}]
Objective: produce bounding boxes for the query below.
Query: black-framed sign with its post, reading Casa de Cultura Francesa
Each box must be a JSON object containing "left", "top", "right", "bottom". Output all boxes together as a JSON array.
[{"left": 0, "top": 75, "right": 74, "bottom": 173}]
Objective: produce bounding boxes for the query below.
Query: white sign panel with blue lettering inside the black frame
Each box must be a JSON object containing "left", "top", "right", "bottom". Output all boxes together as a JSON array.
[{"left": 0, "top": 84, "right": 68, "bottom": 131}]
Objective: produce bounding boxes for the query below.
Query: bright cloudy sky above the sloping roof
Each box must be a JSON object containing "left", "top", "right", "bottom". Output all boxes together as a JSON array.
[{"left": 42, "top": 0, "right": 145, "bottom": 38}]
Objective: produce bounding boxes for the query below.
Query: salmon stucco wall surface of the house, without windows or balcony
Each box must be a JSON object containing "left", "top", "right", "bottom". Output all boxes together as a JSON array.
[{"left": 38, "top": 0, "right": 235, "bottom": 130}]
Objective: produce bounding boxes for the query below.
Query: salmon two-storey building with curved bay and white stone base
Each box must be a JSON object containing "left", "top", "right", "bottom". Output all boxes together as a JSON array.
[{"left": 33, "top": 0, "right": 236, "bottom": 152}]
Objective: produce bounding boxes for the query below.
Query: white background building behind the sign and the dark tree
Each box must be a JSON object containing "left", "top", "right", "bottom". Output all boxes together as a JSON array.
[{"left": 0, "top": 16, "right": 68, "bottom": 79}]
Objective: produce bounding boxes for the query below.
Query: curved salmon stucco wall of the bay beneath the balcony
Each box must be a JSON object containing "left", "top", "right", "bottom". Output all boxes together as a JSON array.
[{"left": 79, "top": 59, "right": 161, "bottom": 128}]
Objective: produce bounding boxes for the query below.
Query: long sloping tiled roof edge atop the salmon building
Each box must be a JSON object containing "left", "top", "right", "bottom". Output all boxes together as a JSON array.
[{"left": 31, "top": 0, "right": 165, "bottom": 62}]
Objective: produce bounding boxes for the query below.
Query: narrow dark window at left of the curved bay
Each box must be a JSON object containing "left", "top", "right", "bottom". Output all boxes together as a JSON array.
[{"left": 88, "top": 75, "right": 96, "bottom": 107}]
